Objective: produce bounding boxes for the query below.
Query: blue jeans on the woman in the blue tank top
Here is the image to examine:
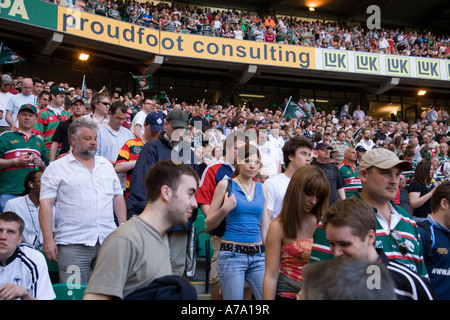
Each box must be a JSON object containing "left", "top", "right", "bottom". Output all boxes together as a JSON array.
[{"left": 218, "top": 250, "right": 266, "bottom": 300}]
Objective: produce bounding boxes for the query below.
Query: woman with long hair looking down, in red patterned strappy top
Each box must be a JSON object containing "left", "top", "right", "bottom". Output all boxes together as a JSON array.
[{"left": 263, "top": 165, "right": 330, "bottom": 300}]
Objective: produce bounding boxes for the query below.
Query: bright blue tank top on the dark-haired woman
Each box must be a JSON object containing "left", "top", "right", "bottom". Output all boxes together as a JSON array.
[{"left": 222, "top": 181, "right": 265, "bottom": 243}]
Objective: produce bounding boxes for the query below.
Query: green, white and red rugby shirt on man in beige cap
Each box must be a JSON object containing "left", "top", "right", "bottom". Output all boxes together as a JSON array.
[{"left": 310, "top": 192, "right": 428, "bottom": 277}]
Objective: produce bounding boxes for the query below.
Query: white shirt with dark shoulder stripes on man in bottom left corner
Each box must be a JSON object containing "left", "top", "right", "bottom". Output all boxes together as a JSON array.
[{"left": 0, "top": 244, "right": 56, "bottom": 300}]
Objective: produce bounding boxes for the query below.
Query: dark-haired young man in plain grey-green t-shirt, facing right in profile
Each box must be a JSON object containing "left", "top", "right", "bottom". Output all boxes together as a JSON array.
[{"left": 84, "top": 160, "right": 198, "bottom": 300}]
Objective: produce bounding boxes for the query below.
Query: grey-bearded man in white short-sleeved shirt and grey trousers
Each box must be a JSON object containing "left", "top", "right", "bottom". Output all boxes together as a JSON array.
[{"left": 39, "top": 117, "right": 126, "bottom": 283}]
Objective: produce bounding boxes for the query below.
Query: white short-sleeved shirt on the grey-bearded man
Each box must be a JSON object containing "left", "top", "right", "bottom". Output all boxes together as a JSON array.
[{"left": 40, "top": 152, "right": 123, "bottom": 246}]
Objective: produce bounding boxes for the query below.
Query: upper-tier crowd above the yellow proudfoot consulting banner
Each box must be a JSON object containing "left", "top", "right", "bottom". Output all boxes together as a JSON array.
[{"left": 43, "top": 0, "right": 450, "bottom": 59}]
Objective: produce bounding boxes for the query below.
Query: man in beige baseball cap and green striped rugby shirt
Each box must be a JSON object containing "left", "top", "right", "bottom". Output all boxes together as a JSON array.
[{"left": 311, "top": 148, "right": 427, "bottom": 276}]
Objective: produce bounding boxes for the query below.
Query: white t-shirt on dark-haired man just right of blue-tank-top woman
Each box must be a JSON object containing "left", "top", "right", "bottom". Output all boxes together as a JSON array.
[{"left": 264, "top": 173, "right": 291, "bottom": 220}]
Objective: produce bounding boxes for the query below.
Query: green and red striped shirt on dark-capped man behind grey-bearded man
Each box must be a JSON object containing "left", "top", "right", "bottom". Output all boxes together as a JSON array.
[{"left": 33, "top": 107, "right": 71, "bottom": 156}]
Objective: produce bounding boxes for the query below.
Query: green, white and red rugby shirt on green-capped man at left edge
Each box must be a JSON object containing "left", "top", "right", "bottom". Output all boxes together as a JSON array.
[{"left": 0, "top": 128, "right": 50, "bottom": 195}]
